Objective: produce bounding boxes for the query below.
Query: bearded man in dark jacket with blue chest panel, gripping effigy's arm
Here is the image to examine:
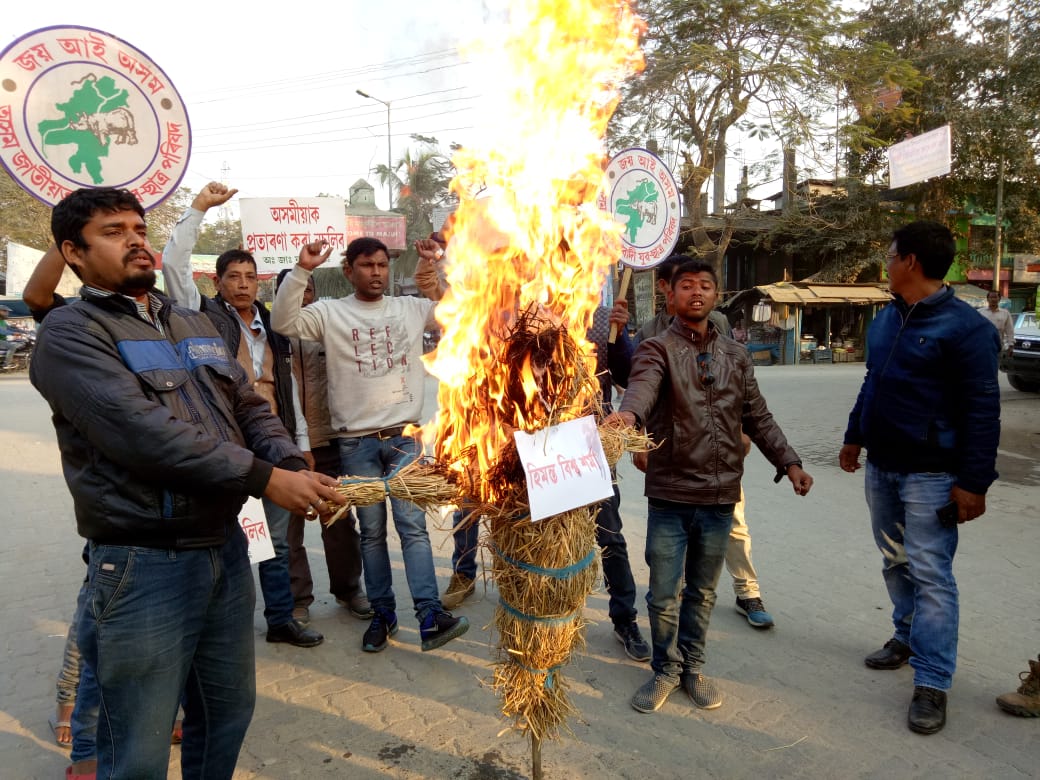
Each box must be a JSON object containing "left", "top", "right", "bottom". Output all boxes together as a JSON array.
[{"left": 30, "top": 188, "right": 342, "bottom": 778}]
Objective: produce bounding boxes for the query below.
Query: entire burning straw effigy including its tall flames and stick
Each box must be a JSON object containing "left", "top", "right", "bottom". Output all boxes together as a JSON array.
[{"left": 328, "top": 0, "right": 646, "bottom": 777}]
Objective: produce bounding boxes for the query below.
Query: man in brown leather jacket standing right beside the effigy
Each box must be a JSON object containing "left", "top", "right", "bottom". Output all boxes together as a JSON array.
[{"left": 608, "top": 260, "right": 812, "bottom": 712}]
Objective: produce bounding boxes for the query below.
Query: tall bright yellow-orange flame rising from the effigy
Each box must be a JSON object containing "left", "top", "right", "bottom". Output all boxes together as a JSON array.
[{"left": 422, "top": 0, "right": 643, "bottom": 500}]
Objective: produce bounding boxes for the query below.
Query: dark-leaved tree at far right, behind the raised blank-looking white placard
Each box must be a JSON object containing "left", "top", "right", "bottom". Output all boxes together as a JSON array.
[{"left": 766, "top": 0, "right": 1040, "bottom": 281}]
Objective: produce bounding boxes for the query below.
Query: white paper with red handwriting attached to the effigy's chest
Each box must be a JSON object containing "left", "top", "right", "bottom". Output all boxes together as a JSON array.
[{"left": 513, "top": 417, "right": 614, "bottom": 521}]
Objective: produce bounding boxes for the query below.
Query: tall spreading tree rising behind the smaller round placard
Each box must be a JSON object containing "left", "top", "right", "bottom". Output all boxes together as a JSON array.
[{"left": 612, "top": 0, "right": 915, "bottom": 280}]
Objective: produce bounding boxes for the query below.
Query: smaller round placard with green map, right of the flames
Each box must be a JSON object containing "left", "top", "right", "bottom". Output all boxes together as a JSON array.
[{"left": 600, "top": 148, "right": 680, "bottom": 269}]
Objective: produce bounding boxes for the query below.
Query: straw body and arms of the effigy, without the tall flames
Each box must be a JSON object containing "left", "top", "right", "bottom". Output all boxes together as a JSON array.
[{"left": 333, "top": 307, "right": 649, "bottom": 769}]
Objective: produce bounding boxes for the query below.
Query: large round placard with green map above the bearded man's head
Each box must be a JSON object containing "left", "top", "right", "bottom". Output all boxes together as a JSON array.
[{"left": 0, "top": 27, "right": 191, "bottom": 209}]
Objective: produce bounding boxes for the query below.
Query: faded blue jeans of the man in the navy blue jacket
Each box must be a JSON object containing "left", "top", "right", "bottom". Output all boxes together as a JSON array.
[{"left": 865, "top": 461, "right": 960, "bottom": 691}]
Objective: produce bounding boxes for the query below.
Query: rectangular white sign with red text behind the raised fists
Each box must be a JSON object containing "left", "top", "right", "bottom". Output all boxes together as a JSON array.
[{"left": 238, "top": 198, "right": 346, "bottom": 274}]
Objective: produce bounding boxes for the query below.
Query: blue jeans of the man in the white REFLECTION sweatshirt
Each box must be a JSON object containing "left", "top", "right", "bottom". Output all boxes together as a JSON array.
[{"left": 339, "top": 436, "right": 443, "bottom": 624}]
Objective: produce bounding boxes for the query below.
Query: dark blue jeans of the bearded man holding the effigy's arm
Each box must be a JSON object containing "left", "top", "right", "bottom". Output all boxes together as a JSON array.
[{"left": 78, "top": 528, "right": 256, "bottom": 780}]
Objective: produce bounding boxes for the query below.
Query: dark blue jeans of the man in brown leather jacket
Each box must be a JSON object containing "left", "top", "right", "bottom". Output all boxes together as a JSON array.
[{"left": 646, "top": 507, "right": 733, "bottom": 677}]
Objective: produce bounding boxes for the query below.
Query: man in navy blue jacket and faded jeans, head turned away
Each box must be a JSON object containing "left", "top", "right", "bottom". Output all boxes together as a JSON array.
[{"left": 838, "top": 222, "right": 1000, "bottom": 734}]
